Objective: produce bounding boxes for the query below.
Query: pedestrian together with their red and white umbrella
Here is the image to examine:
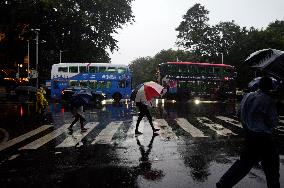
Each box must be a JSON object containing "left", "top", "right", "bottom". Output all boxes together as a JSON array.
[{"left": 131, "top": 81, "right": 164, "bottom": 134}]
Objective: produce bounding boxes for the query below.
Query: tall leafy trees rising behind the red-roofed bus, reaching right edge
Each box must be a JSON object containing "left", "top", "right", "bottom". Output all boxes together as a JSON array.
[{"left": 176, "top": 4, "right": 284, "bottom": 87}]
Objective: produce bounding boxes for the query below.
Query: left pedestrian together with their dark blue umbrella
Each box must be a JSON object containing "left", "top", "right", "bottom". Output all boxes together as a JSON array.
[{"left": 68, "top": 90, "right": 92, "bottom": 133}]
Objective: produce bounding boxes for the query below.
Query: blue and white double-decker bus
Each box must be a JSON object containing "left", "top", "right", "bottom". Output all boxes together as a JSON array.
[{"left": 51, "top": 63, "right": 131, "bottom": 100}]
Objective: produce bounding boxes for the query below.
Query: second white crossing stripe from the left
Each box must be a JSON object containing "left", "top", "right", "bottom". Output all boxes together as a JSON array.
[{"left": 19, "top": 124, "right": 70, "bottom": 150}]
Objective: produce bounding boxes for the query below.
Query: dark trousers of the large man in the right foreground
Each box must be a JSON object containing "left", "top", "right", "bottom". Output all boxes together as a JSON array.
[{"left": 216, "top": 132, "right": 280, "bottom": 188}]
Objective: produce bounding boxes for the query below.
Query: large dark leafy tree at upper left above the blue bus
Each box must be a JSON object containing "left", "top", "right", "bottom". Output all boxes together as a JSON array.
[{"left": 0, "top": 0, "right": 134, "bottom": 80}]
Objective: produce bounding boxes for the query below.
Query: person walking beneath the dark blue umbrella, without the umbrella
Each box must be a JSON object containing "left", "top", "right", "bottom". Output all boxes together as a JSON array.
[{"left": 68, "top": 93, "right": 87, "bottom": 133}]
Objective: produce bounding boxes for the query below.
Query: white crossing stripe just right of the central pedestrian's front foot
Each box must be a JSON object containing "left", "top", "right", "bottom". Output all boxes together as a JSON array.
[{"left": 154, "top": 119, "right": 178, "bottom": 139}]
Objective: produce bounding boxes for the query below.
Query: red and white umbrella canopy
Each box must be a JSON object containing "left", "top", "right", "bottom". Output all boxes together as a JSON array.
[{"left": 133, "top": 81, "right": 164, "bottom": 102}]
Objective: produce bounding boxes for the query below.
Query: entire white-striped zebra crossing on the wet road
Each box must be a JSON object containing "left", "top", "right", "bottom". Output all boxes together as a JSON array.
[{"left": 0, "top": 116, "right": 283, "bottom": 151}]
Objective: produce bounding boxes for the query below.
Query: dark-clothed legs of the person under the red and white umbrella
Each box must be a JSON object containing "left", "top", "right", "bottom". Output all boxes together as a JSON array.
[{"left": 135, "top": 102, "right": 160, "bottom": 134}]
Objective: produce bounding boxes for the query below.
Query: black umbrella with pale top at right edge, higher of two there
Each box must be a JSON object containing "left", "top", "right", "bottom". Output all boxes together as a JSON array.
[{"left": 244, "top": 49, "right": 284, "bottom": 79}]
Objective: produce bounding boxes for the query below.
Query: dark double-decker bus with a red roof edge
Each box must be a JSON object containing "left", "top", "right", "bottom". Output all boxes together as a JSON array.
[{"left": 157, "top": 62, "right": 236, "bottom": 100}]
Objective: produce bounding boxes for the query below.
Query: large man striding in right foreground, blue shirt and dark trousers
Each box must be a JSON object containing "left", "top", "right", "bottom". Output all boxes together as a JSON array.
[{"left": 216, "top": 77, "right": 280, "bottom": 188}]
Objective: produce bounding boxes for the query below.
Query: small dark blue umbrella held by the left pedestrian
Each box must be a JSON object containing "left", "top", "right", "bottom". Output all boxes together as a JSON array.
[{"left": 72, "top": 90, "right": 93, "bottom": 107}]
